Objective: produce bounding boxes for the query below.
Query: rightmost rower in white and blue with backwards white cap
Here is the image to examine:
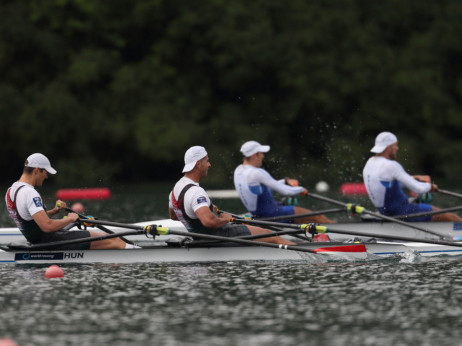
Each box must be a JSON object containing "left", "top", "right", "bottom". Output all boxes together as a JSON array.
[{"left": 363, "top": 132, "right": 462, "bottom": 222}]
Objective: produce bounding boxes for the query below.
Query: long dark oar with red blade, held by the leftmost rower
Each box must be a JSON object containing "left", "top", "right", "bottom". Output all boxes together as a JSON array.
[{"left": 82, "top": 220, "right": 366, "bottom": 254}]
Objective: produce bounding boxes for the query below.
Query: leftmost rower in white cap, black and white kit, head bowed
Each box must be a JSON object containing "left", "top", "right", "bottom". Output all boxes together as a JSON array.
[{"left": 5, "top": 153, "right": 133, "bottom": 250}]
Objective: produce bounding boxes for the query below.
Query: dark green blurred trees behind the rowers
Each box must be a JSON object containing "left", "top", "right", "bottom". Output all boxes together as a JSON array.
[{"left": 0, "top": 0, "right": 462, "bottom": 185}]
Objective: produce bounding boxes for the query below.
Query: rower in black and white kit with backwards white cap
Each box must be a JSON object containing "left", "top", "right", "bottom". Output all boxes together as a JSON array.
[{"left": 169, "top": 146, "right": 294, "bottom": 245}]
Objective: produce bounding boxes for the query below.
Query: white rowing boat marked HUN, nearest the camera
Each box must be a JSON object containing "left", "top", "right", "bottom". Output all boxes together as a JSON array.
[{"left": 0, "top": 238, "right": 462, "bottom": 264}]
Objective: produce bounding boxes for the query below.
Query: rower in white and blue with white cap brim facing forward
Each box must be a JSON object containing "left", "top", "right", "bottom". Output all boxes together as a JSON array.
[{"left": 234, "top": 141, "right": 334, "bottom": 223}]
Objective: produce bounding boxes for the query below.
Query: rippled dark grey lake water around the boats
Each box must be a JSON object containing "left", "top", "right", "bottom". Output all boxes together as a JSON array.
[{"left": 0, "top": 182, "right": 462, "bottom": 346}]
